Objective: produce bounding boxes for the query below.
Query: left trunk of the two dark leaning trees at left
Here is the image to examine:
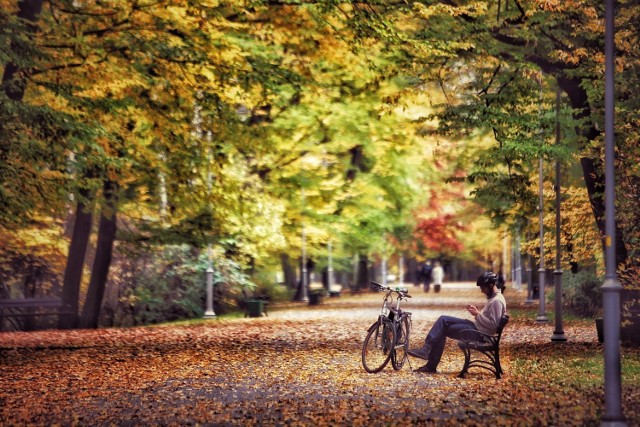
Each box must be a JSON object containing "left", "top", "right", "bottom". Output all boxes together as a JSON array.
[{"left": 58, "top": 196, "right": 93, "bottom": 329}]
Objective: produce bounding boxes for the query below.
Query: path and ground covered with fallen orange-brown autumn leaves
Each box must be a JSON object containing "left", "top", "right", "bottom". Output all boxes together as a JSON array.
[{"left": 0, "top": 286, "right": 640, "bottom": 426}]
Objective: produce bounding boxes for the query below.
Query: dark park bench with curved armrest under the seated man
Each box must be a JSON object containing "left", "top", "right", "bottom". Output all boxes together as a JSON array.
[{"left": 458, "top": 314, "right": 509, "bottom": 379}]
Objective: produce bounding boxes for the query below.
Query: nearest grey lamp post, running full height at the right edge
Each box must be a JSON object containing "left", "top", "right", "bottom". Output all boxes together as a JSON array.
[{"left": 601, "top": 0, "right": 627, "bottom": 427}]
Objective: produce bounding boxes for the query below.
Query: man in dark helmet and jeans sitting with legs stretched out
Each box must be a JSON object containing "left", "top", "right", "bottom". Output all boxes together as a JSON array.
[{"left": 407, "top": 271, "right": 507, "bottom": 372}]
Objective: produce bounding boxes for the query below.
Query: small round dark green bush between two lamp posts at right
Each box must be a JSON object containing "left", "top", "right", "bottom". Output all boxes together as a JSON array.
[{"left": 563, "top": 271, "right": 604, "bottom": 317}]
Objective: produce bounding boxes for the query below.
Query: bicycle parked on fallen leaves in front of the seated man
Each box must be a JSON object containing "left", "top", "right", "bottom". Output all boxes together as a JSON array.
[{"left": 362, "top": 281, "right": 411, "bottom": 374}]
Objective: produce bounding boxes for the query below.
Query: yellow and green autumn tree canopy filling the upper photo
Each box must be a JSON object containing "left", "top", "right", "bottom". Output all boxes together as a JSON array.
[{"left": 0, "top": 0, "right": 640, "bottom": 326}]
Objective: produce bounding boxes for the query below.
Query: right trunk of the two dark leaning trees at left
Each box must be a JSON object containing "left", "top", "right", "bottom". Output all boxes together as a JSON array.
[{"left": 80, "top": 180, "right": 117, "bottom": 328}]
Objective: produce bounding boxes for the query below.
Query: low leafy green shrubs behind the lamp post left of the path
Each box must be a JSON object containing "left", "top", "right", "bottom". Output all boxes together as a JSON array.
[{"left": 103, "top": 245, "right": 255, "bottom": 326}]
